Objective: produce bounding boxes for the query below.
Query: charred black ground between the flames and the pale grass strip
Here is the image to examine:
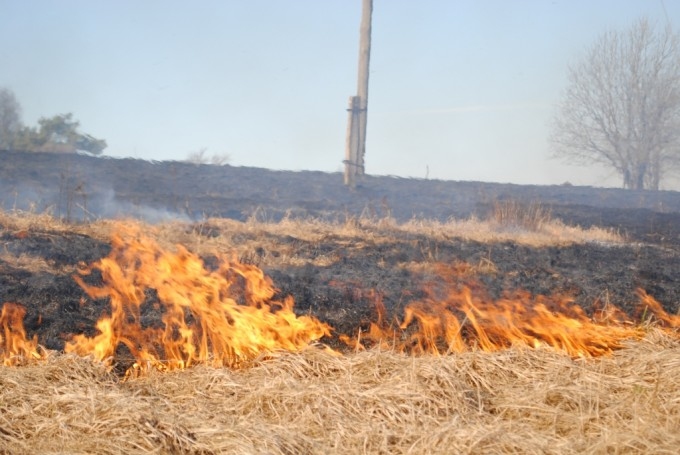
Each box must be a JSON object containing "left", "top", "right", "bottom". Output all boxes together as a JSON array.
[{"left": 0, "top": 213, "right": 680, "bottom": 349}]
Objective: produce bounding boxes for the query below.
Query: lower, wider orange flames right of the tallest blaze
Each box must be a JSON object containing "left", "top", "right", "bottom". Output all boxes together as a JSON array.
[{"left": 342, "top": 268, "right": 680, "bottom": 357}]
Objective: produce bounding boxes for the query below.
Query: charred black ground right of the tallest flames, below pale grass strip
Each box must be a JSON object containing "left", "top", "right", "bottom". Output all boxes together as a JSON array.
[{"left": 266, "top": 228, "right": 680, "bottom": 342}]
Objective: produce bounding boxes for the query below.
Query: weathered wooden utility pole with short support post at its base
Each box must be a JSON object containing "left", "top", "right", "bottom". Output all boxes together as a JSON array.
[{"left": 344, "top": 0, "right": 373, "bottom": 188}]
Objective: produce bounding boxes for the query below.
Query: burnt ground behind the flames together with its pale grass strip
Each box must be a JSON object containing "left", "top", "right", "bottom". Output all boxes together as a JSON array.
[{"left": 0, "top": 215, "right": 680, "bottom": 356}]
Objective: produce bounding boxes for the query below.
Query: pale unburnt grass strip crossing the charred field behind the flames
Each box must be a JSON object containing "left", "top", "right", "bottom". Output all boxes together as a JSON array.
[{"left": 0, "top": 206, "right": 624, "bottom": 254}]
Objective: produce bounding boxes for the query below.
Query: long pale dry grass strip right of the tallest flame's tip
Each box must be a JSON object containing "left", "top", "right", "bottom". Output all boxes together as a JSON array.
[{"left": 157, "top": 209, "right": 625, "bottom": 266}]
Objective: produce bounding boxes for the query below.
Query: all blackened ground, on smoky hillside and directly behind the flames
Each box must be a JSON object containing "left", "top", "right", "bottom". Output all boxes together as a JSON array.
[{"left": 0, "top": 152, "right": 680, "bottom": 349}]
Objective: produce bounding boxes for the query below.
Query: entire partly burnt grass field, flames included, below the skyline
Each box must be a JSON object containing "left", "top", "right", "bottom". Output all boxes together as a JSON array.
[{"left": 0, "top": 155, "right": 680, "bottom": 454}]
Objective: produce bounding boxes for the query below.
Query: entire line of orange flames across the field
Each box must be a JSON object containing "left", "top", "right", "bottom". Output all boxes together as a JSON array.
[{"left": 0, "top": 225, "right": 680, "bottom": 375}]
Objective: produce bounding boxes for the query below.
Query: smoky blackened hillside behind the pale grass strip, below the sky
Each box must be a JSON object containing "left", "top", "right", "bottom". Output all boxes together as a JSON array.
[{"left": 0, "top": 151, "right": 680, "bottom": 244}]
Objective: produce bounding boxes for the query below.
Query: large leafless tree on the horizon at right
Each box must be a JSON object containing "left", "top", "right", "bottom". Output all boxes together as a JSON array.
[{"left": 551, "top": 18, "right": 680, "bottom": 190}]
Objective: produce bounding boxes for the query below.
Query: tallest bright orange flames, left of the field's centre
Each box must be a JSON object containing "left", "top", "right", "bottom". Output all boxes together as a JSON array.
[{"left": 65, "top": 226, "right": 331, "bottom": 370}]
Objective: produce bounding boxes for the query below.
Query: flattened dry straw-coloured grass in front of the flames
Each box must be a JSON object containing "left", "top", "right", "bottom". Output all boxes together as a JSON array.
[{"left": 0, "top": 330, "right": 680, "bottom": 454}]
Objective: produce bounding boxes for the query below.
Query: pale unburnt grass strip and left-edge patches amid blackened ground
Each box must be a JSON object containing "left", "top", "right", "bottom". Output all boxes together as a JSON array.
[{"left": 0, "top": 204, "right": 625, "bottom": 282}]
